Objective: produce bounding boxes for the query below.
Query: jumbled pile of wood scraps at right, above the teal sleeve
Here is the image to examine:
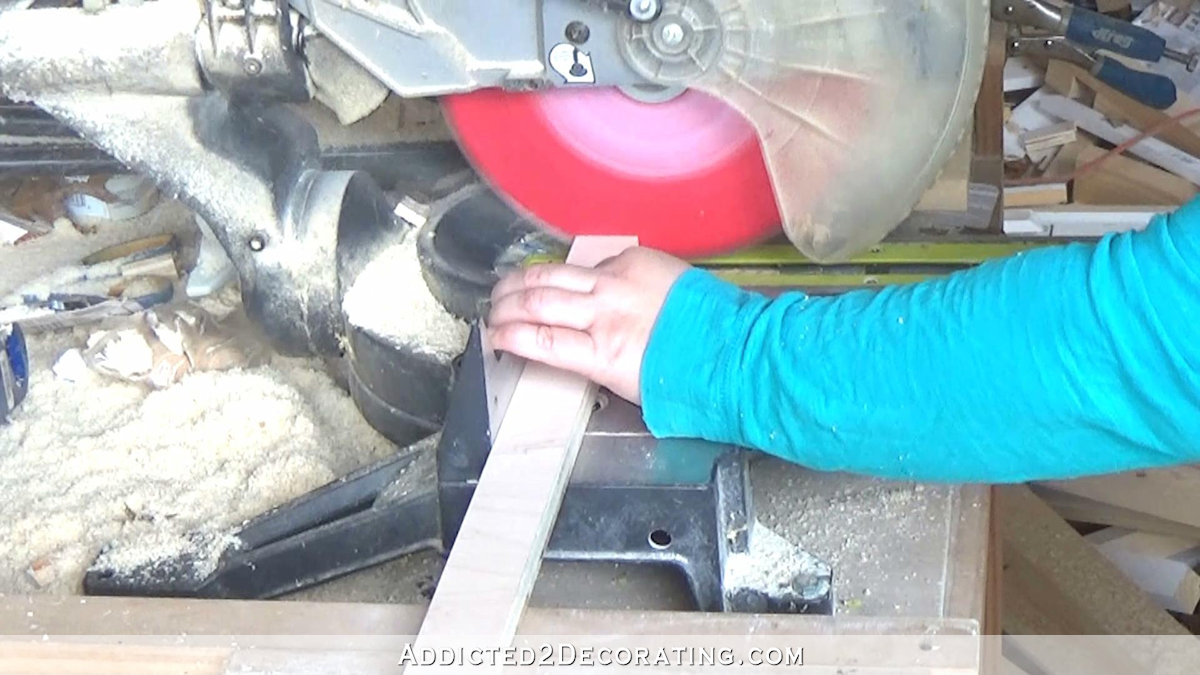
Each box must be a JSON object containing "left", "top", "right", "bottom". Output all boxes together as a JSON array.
[{"left": 1004, "top": 0, "right": 1200, "bottom": 235}]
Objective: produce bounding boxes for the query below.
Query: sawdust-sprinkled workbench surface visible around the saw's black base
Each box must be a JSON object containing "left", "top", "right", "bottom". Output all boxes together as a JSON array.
[{"left": 289, "top": 456, "right": 989, "bottom": 620}]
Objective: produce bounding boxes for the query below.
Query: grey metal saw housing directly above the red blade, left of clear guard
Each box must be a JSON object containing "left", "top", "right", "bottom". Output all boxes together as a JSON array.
[{"left": 290, "top": 0, "right": 676, "bottom": 97}]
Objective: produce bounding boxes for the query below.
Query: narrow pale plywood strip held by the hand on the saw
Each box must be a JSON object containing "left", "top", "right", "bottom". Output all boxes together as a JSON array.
[{"left": 418, "top": 237, "right": 637, "bottom": 649}]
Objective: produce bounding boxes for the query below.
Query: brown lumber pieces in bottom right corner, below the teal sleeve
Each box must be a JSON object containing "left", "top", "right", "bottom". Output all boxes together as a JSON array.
[{"left": 995, "top": 477, "right": 1200, "bottom": 675}]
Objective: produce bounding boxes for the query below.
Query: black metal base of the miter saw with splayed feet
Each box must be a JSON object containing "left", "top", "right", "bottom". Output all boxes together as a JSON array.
[{"left": 84, "top": 330, "right": 833, "bottom": 614}]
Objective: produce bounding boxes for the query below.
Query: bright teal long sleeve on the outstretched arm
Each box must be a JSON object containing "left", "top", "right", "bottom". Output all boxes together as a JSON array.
[{"left": 641, "top": 201, "right": 1200, "bottom": 483}]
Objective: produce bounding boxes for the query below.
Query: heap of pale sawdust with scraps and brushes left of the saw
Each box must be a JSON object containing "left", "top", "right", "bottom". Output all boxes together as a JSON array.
[{"left": 0, "top": 173, "right": 400, "bottom": 595}]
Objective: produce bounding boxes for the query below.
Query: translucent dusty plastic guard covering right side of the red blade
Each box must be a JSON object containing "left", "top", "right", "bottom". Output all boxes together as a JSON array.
[{"left": 643, "top": 0, "right": 989, "bottom": 261}]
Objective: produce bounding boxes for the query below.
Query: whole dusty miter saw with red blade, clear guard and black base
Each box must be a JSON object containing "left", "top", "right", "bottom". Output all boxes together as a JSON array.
[{"left": 0, "top": 0, "right": 990, "bottom": 611}]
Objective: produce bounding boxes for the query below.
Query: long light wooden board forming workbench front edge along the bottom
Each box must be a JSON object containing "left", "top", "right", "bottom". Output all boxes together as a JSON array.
[{"left": 0, "top": 596, "right": 978, "bottom": 675}]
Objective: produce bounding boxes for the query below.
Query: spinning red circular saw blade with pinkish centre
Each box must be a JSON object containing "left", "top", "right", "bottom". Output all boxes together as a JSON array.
[{"left": 443, "top": 88, "right": 780, "bottom": 256}]
